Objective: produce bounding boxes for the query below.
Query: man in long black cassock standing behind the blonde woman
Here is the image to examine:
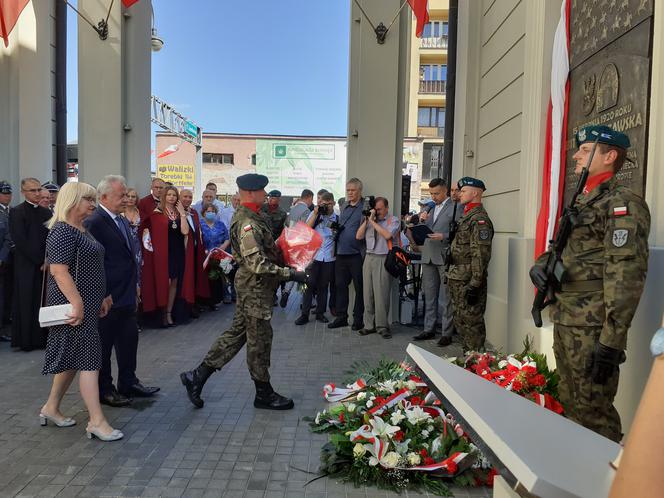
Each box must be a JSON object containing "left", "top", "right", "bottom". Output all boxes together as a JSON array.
[{"left": 9, "top": 178, "right": 51, "bottom": 351}]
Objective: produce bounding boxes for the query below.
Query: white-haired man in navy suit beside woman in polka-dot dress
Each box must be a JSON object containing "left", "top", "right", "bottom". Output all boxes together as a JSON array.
[{"left": 85, "top": 175, "right": 159, "bottom": 406}]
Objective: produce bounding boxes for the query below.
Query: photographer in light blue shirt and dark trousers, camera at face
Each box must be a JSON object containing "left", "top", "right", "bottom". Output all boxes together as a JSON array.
[{"left": 295, "top": 192, "right": 338, "bottom": 325}]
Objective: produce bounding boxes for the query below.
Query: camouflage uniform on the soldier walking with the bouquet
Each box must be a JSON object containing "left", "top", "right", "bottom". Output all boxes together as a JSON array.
[{"left": 203, "top": 205, "right": 290, "bottom": 382}]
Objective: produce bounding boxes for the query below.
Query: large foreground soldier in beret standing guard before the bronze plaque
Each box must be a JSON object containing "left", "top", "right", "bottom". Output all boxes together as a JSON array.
[{"left": 530, "top": 126, "right": 650, "bottom": 442}]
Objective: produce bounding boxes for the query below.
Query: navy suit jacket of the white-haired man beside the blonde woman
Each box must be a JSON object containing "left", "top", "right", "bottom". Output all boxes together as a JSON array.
[{"left": 85, "top": 207, "right": 138, "bottom": 308}]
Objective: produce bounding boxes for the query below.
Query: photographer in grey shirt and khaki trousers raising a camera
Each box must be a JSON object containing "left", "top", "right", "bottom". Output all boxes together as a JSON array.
[{"left": 355, "top": 197, "right": 401, "bottom": 339}]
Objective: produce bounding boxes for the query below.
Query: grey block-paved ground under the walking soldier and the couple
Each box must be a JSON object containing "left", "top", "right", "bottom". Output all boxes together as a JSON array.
[{"left": 0, "top": 296, "right": 491, "bottom": 498}]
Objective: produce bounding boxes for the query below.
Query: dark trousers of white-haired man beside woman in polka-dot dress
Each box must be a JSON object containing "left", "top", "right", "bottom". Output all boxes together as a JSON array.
[{"left": 99, "top": 306, "right": 138, "bottom": 396}]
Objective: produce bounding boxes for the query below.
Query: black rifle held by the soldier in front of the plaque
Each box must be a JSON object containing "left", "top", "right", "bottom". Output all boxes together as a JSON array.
[{"left": 530, "top": 131, "right": 600, "bottom": 328}]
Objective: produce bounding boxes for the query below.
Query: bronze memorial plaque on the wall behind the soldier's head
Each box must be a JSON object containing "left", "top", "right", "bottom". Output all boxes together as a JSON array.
[{"left": 564, "top": 0, "right": 653, "bottom": 204}]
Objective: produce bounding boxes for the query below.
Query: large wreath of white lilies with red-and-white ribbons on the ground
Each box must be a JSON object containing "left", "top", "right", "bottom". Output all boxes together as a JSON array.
[{"left": 308, "top": 360, "right": 492, "bottom": 496}]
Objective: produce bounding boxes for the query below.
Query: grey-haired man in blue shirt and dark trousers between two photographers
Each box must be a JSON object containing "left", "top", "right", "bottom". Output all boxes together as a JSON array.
[{"left": 328, "top": 178, "right": 365, "bottom": 331}]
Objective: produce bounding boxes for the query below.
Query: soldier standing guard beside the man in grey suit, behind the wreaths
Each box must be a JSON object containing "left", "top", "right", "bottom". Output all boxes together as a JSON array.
[{"left": 447, "top": 177, "right": 493, "bottom": 351}]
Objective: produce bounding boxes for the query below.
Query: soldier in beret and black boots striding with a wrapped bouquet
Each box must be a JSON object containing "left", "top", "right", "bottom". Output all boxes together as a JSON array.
[{"left": 180, "top": 173, "right": 307, "bottom": 410}]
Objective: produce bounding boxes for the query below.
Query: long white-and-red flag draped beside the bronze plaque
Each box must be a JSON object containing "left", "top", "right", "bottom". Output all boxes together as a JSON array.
[{"left": 535, "top": 0, "right": 570, "bottom": 258}]
